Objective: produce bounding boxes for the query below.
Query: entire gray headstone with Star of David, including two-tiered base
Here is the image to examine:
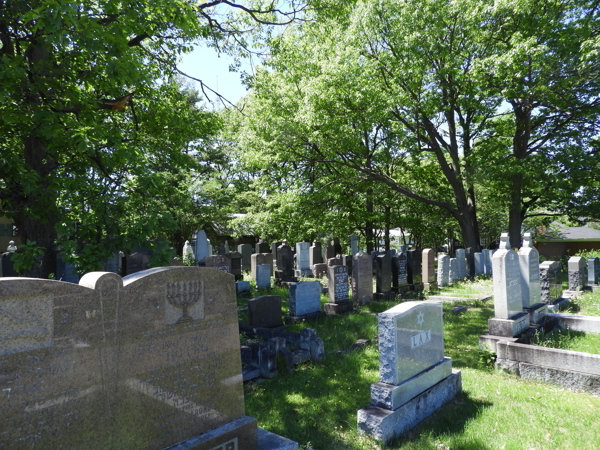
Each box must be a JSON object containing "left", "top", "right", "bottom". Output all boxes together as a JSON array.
[{"left": 357, "top": 302, "right": 461, "bottom": 444}]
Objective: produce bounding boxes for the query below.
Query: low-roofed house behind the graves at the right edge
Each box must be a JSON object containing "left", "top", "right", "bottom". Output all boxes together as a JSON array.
[{"left": 535, "top": 222, "right": 600, "bottom": 259}]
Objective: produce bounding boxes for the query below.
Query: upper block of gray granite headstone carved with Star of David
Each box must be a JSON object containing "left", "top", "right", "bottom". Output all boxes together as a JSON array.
[{"left": 379, "top": 302, "right": 444, "bottom": 385}]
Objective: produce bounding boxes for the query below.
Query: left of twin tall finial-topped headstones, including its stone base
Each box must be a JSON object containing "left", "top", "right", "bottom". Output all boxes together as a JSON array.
[{"left": 488, "top": 233, "right": 529, "bottom": 337}]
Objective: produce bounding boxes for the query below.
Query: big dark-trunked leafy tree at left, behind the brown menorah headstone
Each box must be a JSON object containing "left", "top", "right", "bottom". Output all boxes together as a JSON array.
[{"left": 0, "top": 0, "right": 314, "bottom": 277}]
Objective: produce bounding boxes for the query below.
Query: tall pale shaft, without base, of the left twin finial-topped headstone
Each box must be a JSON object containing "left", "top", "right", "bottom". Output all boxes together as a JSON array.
[{"left": 492, "top": 233, "right": 523, "bottom": 319}]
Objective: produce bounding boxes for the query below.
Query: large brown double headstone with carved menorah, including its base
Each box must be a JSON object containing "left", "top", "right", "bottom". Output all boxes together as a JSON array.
[{"left": 0, "top": 267, "right": 258, "bottom": 450}]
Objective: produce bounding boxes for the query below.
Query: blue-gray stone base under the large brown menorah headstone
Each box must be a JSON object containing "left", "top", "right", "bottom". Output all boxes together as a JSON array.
[{"left": 165, "top": 416, "right": 260, "bottom": 450}]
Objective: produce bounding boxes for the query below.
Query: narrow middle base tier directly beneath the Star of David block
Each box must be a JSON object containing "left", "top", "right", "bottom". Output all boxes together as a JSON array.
[{"left": 371, "top": 358, "right": 452, "bottom": 411}]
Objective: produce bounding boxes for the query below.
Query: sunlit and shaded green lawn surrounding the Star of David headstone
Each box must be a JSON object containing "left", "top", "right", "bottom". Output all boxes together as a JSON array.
[{"left": 237, "top": 272, "right": 600, "bottom": 450}]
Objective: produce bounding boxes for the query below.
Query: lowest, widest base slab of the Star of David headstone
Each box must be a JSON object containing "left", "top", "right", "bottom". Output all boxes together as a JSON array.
[{"left": 357, "top": 369, "right": 461, "bottom": 444}]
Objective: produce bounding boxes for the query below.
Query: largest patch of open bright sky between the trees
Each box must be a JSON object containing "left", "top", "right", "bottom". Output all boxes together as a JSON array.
[{"left": 177, "top": 46, "right": 252, "bottom": 109}]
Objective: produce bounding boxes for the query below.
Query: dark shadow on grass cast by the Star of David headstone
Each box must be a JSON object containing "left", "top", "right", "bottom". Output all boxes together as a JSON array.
[{"left": 388, "top": 391, "right": 493, "bottom": 450}]
